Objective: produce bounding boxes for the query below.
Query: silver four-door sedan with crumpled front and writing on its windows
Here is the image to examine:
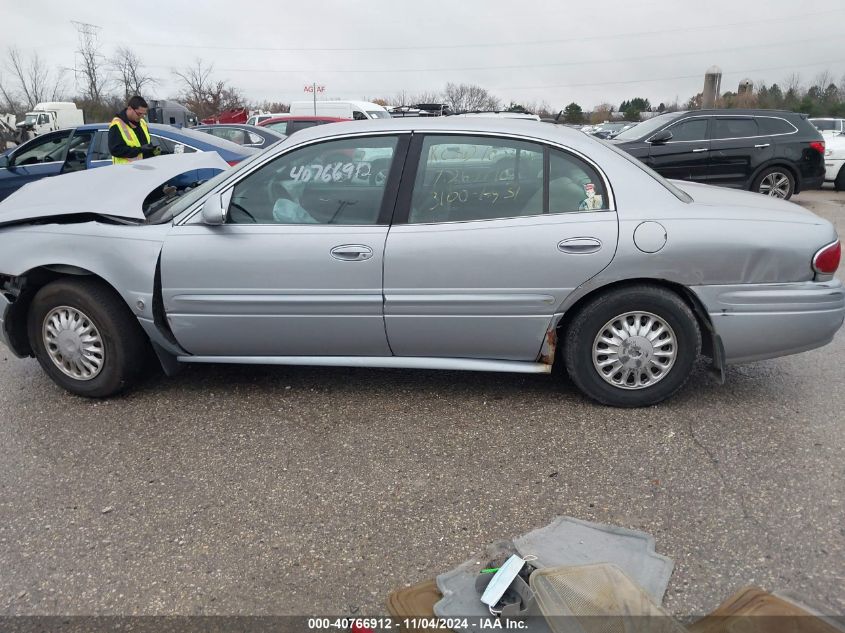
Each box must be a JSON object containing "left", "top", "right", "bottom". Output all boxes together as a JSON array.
[{"left": 0, "top": 118, "right": 845, "bottom": 406}]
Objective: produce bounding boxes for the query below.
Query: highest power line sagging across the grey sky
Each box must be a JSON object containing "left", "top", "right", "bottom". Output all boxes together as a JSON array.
[{"left": 122, "top": 9, "right": 845, "bottom": 53}]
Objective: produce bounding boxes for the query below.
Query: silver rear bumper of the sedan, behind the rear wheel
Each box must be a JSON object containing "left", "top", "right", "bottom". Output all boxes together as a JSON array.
[{"left": 691, "top": 279, "right": 845, "bottom": 364}]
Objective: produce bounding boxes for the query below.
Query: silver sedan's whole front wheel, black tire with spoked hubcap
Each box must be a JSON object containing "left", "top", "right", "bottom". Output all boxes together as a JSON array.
[{"left": 27, "top": 278, "right": 149, "bottom": 398}]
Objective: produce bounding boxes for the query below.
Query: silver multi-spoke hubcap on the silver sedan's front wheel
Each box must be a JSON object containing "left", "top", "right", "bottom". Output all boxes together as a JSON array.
[{"left": 42, "top": 306, "right": 105, "bottom": 380}]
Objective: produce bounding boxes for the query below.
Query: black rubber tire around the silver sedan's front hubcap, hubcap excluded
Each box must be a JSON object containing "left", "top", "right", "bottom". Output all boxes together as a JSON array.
[{"left": 27, "top": 280, "right": 143, "bottom": 398}]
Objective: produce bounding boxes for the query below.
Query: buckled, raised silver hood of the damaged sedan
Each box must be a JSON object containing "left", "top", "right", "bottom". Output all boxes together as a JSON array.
[{"left": 0, "top": 152, "right": 229, "bottom": 225}]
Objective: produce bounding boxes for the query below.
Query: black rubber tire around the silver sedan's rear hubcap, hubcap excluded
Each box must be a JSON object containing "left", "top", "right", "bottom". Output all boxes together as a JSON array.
[{"left": 564, "top": 288, "right": 701, "bottom": 407}]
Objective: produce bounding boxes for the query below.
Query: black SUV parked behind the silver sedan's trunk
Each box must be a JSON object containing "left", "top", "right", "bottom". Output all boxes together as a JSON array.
[{"left": 610, "top": 110, "right": 825, "bottom": 199}]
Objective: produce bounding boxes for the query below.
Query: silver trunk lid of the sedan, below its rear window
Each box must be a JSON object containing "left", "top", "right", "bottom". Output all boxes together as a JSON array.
[{"left": 671, "top": 180, "right": 824, "bottom": 224}]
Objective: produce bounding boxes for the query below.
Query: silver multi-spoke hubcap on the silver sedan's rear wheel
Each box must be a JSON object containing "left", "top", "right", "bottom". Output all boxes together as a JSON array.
[{"left": 593, "top": 312, "right": 677, "bottom": 389}]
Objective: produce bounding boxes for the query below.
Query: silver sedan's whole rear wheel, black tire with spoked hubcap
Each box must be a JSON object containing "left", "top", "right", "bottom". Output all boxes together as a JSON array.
[{"left": 563, "top": 285, "right": 701, "bottom": 407}]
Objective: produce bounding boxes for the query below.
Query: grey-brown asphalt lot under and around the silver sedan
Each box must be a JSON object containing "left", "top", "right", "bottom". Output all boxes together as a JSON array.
[{"left": 0, "top": 190, "right": 845, "bottom": 616}]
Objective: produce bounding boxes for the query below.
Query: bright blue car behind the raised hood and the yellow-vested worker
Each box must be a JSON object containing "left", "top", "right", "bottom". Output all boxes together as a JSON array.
[{"left": 0, "top": 123, "right": 258, "bottom": 200}]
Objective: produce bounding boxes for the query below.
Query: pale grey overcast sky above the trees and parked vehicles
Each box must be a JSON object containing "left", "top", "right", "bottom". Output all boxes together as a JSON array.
[{"left": 0, "top": 0, "right": 845, "bottom": 109}]
